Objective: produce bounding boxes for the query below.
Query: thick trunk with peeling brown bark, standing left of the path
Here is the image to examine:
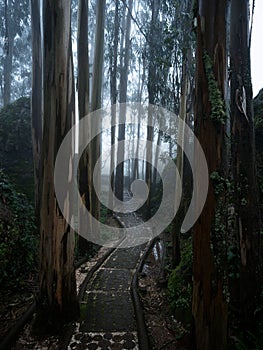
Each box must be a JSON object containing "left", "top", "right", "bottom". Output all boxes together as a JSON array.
[{"left": 37, "top": 0, "right": 78, "bottom": 327}]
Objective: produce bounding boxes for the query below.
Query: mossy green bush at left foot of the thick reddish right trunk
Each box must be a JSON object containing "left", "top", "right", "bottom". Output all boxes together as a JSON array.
[{"left": 168, "top": 239, "right": 193, "bottom": 313}]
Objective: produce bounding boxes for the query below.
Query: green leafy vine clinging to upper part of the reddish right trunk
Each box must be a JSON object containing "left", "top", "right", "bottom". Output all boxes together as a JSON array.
[{"left": 203, "top": 52, "right": 227, "bottom": 124}]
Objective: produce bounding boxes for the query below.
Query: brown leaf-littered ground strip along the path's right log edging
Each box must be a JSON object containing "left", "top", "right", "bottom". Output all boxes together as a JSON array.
[{"left": 139, "top": 239, "right": 190, "bottom": 350}]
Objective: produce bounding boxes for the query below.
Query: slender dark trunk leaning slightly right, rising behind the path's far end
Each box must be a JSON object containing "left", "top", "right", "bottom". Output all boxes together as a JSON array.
[{"left": 115, "top": 0, "right": 133, "bottom": 201}]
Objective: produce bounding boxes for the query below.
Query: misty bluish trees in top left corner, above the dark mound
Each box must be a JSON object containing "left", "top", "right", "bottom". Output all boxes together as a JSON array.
[{"left": 0, "top": 0, "right": 31, "bottom": 105}]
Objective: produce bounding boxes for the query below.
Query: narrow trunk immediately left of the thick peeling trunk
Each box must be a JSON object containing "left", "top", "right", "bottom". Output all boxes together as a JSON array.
[{"left": 31, "top": 0, "right": 43, "bottom": 218}]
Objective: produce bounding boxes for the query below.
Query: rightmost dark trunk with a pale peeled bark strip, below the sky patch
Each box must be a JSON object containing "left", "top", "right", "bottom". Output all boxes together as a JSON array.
[{"left": 230, "top": 0, "right": 262, "bottom": 325}]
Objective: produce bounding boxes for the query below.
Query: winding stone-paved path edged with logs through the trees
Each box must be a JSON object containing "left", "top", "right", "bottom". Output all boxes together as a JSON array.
[{"left": 68, "top": 192, "right": 152, "bottom": 350}]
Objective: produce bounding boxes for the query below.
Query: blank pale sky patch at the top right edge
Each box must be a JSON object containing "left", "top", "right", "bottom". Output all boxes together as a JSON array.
[{"left": 251, "top": 0, "right": 263, "bottom": 96}]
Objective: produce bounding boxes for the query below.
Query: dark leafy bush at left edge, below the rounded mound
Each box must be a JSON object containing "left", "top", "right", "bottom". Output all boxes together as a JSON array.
[{"left": 0, "top": 170, "right": 37, "bottom": 287}]
